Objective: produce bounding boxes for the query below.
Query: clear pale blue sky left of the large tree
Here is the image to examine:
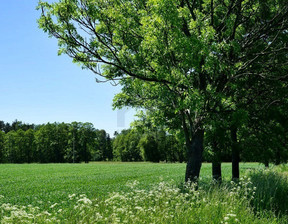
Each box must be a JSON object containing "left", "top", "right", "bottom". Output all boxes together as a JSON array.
[{"left": 0, "top": 0, "right": 135, "bottom": 134}]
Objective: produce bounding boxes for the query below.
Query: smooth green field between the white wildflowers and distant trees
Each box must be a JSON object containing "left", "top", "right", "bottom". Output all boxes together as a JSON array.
[{"left": 0, "top": 162, "right": 259, "bottom": 204}]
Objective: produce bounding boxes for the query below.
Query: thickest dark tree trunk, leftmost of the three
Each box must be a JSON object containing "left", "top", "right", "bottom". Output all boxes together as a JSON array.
[{"left": 185, "top": 130, "right": 204, "bottom": 182}]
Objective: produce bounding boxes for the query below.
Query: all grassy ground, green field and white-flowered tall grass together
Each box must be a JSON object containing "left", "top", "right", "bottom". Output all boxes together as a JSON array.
[{"left": 0, "top": 163, "right": 288, "bottom": 223}]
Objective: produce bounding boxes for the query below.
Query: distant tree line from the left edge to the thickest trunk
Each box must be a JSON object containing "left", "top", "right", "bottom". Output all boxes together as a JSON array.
[{"left": 0, "top": 120, "right": 186, "bottom": 163}]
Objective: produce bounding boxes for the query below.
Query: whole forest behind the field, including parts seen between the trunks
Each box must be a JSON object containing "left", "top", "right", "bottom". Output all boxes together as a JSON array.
[{"left": 0, "top": 117, "right": 288, "bottom": 166}]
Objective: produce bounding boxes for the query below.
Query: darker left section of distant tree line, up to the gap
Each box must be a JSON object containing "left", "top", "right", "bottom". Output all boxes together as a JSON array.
[{"left": 0, "top": 120, "right": 113, "bottom": 163}]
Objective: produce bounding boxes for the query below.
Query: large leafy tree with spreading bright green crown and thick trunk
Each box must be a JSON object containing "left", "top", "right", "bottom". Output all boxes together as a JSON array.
[{"left": 38, "top": 0, "right": 288, "bottom": 181}]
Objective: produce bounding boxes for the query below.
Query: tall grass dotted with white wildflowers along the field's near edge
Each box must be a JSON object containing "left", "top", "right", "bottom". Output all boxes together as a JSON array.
[{"left": 0, "top": 178, "right": 287, "bottom": 224}]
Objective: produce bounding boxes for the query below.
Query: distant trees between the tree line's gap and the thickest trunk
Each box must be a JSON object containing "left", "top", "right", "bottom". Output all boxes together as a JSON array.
[{"left": 113, "top": 128, "right": 186, "bottom": 162}]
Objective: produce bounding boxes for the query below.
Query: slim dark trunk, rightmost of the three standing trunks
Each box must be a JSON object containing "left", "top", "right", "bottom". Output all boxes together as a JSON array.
[{"left": 231, "top": 127, "right": 240, "bottom": 180}]
